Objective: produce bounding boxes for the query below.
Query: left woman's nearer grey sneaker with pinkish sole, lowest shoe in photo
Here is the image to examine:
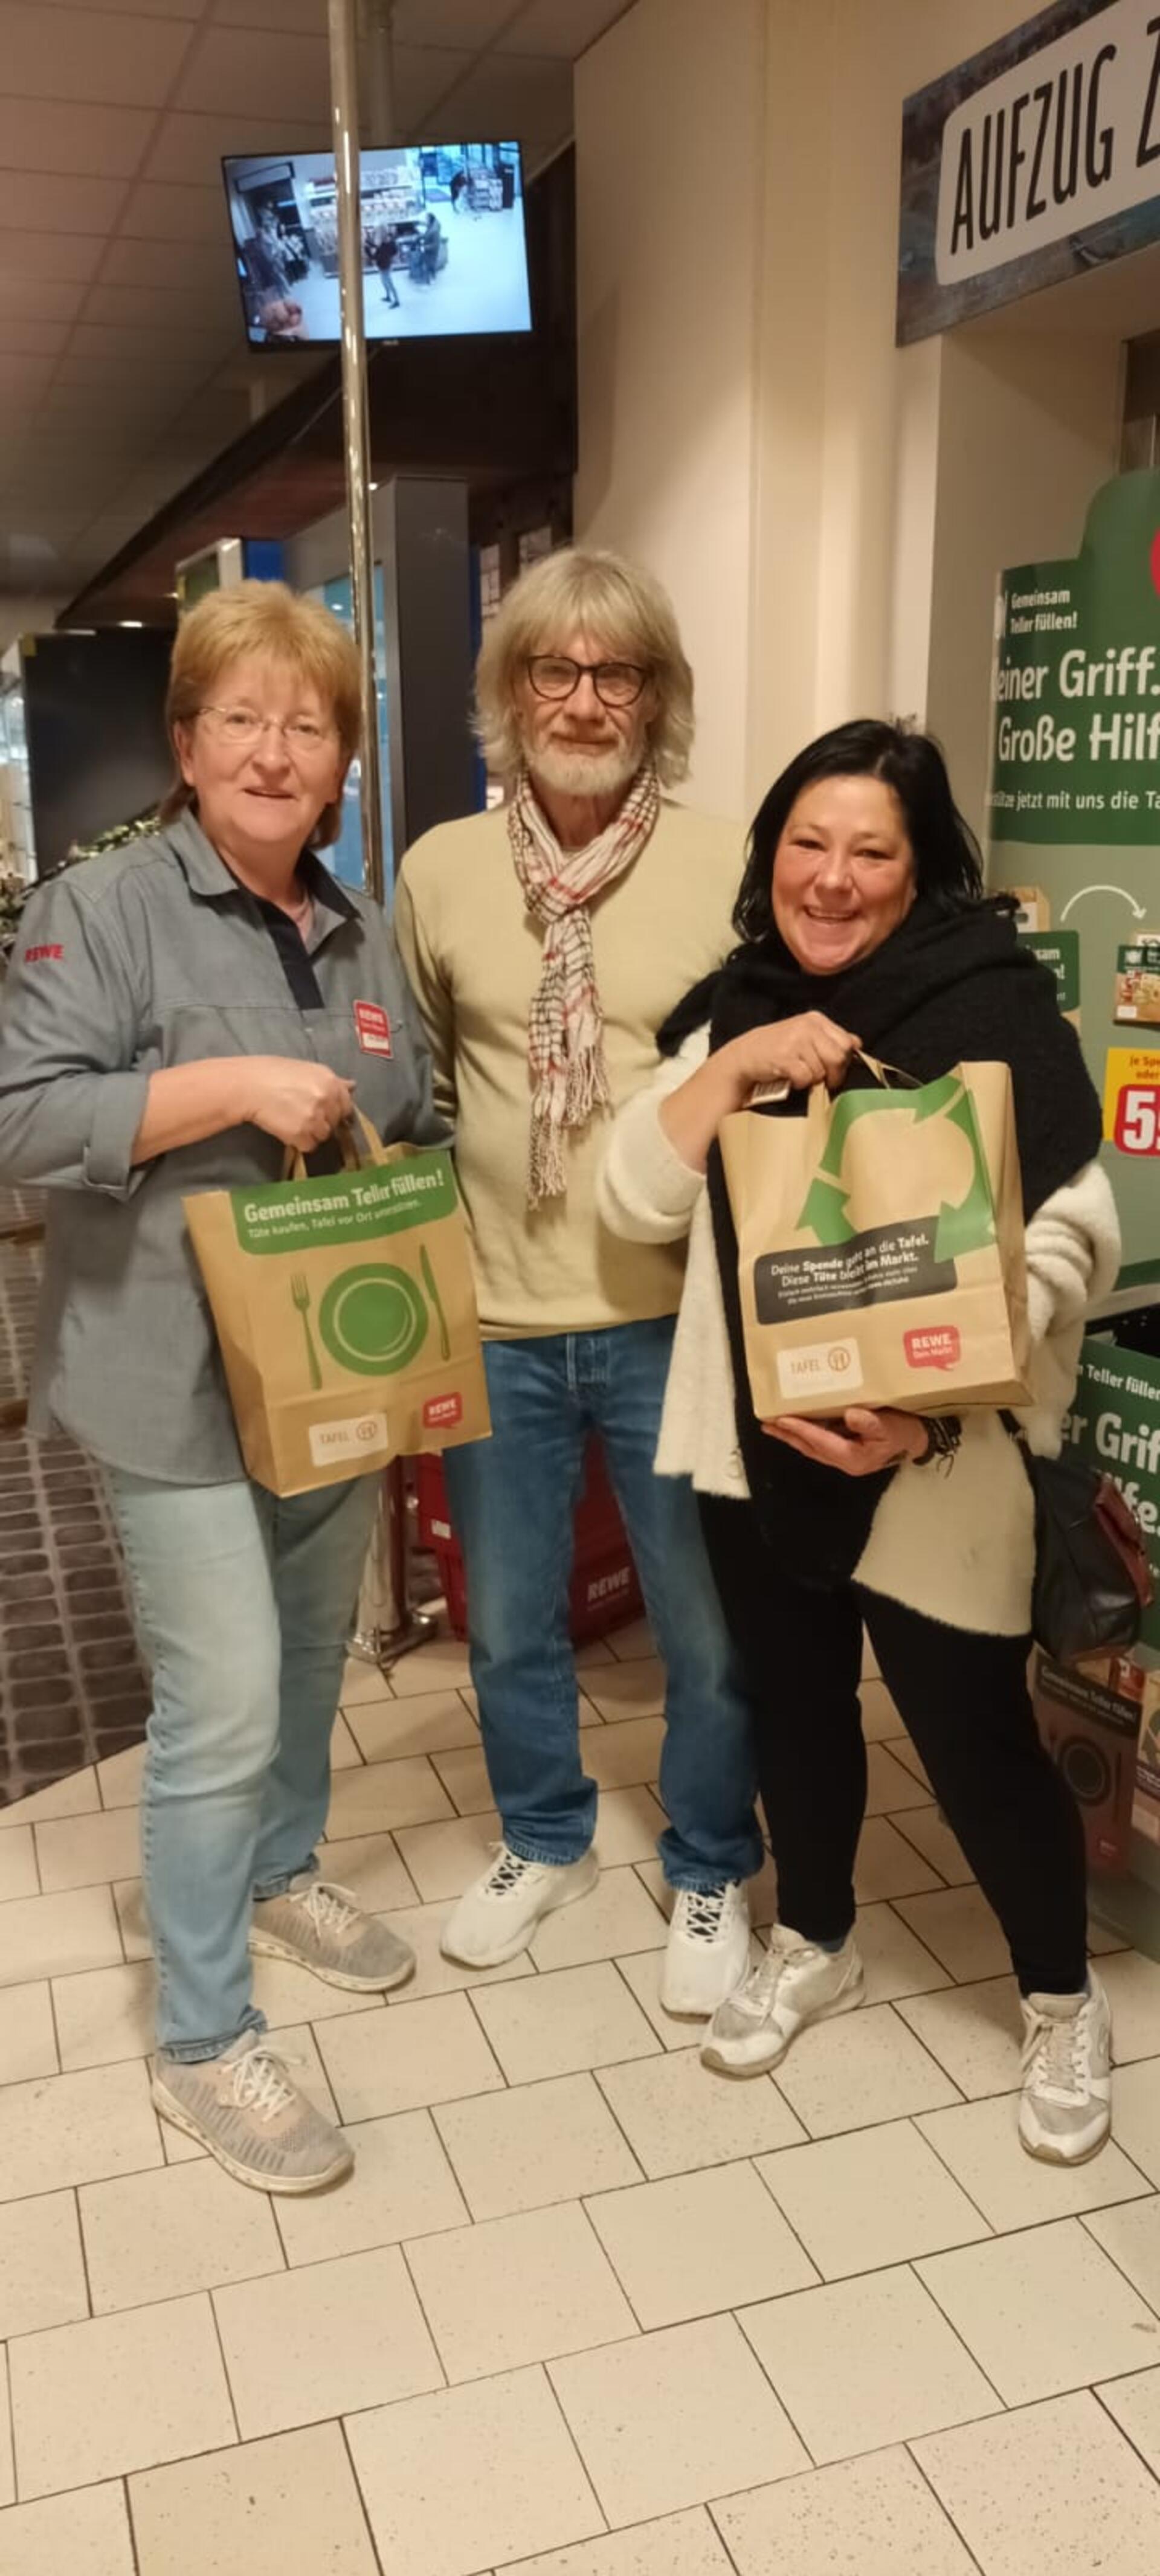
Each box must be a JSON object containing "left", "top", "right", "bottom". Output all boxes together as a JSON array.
[{"left": 152, "top": 2030, "right": 353, "bottom": 2192}]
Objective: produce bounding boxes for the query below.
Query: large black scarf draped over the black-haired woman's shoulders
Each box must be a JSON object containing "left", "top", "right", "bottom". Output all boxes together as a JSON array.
[{"left": 657, "top": 901, "right": 1101, "bottom": 1587}]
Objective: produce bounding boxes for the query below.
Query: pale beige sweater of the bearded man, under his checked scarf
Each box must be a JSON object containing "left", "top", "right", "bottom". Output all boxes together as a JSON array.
[{"left": 395, "top": 803, "right": 743, "bottom": 1339}]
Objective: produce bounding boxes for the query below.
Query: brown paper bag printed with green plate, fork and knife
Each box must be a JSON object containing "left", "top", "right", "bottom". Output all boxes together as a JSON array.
[{"left": 185, "top": 1121, "right": 490, "bottom": 1494}]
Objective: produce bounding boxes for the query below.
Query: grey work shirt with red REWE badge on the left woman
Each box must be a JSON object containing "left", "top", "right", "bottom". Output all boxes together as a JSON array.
[{"left": 0, "top": 814, "right": 446, "bottom": 1484}]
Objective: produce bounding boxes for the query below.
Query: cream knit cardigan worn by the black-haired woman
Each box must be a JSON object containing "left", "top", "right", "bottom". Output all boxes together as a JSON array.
[{"left": 598, "top": 1028, "right": 1119, "bottom": 1636}]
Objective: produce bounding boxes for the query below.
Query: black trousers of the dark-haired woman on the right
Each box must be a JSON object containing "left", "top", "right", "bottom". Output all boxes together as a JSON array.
[{"left": 698, "top": 1494, "right": 1088, "bottom": 1994}]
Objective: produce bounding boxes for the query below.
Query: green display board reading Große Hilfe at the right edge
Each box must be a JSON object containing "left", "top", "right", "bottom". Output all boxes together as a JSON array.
[{"left": 987, "top": 474, "right": 1160, "bottom": 1298}]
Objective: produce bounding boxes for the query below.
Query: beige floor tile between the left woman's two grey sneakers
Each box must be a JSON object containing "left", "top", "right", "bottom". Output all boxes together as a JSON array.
[{"left": 317, "top": 1979, "right": 503, "bottom": 2120}]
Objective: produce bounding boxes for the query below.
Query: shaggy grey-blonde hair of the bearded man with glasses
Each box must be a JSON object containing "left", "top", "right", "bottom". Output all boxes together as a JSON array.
[{"left": 474, "top": 546, "right": 694, "bottom": 786}]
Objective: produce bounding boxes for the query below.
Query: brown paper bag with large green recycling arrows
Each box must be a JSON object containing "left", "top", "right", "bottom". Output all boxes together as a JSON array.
[{"left": 722, "top": 1059, "right": 1028, "bottom": 1422}]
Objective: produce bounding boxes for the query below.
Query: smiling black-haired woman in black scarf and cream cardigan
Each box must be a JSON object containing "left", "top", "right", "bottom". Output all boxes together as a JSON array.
[{"left": 601, "top": 721, "right": 1119, "bottom": 2164}]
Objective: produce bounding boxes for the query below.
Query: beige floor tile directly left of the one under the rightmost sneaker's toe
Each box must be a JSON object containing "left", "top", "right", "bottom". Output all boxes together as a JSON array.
[{"left": 758, "top": 2120, "right": 987, "bottom": 2280}]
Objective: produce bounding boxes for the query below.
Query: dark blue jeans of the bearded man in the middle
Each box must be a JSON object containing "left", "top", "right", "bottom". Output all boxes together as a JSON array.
[{"left": 443, "top": 1316, "right": 763, "bottom": 1889}]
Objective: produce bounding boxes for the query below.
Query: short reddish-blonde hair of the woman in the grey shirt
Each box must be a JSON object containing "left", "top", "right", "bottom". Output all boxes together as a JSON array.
[{"left": 160, "top": 582, "right": 364, "bottom": 850}]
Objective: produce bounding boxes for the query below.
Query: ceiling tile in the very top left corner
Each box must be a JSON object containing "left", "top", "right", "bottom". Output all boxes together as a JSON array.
[{"left": 0, "top": 0, "right": 193, "bottom": 108}]
